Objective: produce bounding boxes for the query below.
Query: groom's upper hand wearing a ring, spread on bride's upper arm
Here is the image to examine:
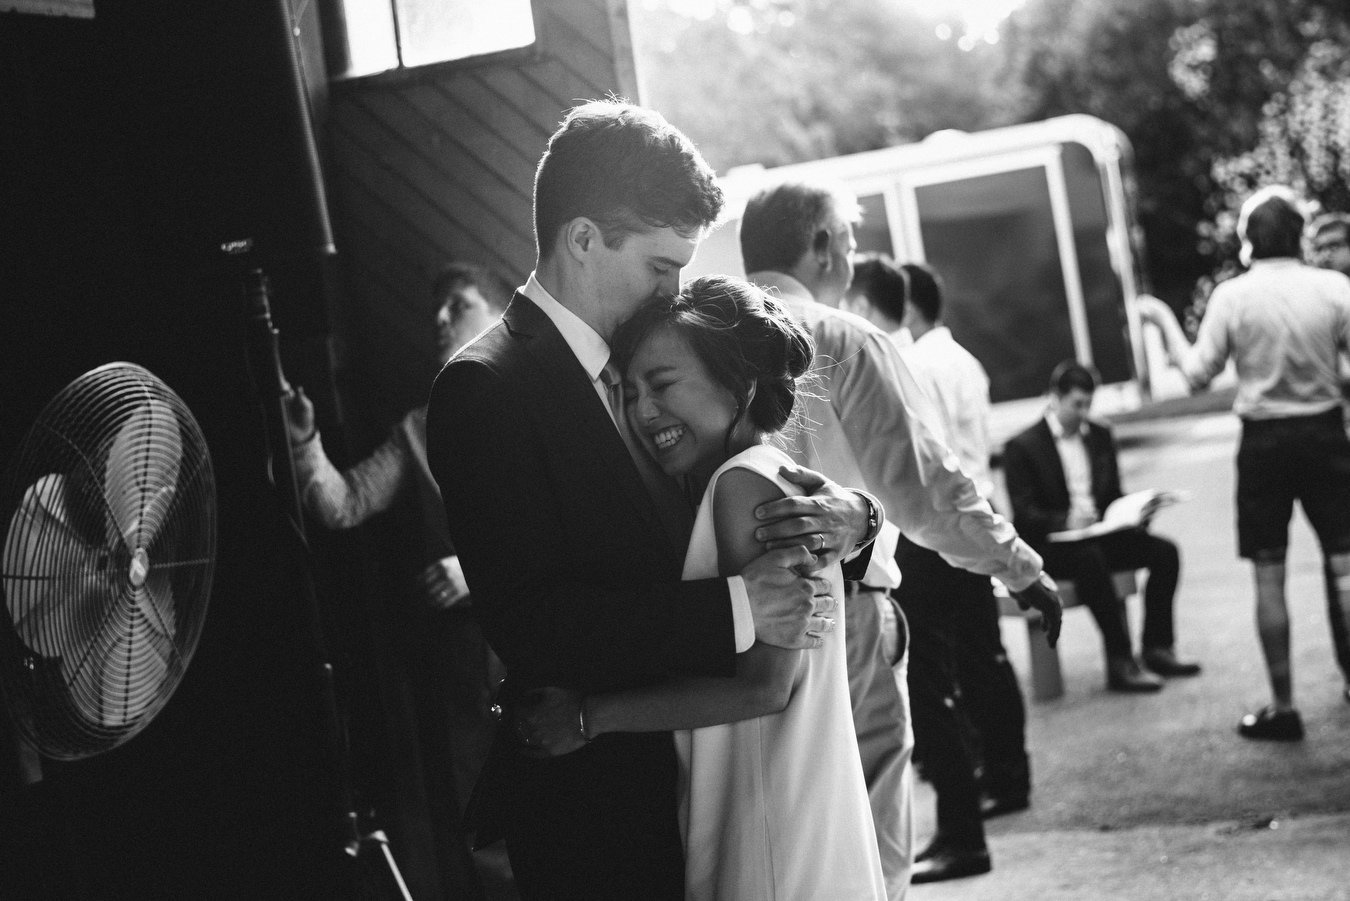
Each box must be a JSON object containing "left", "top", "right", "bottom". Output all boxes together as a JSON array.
[{"left": 755, "top": 466, "right": 871, "bottom": 570}]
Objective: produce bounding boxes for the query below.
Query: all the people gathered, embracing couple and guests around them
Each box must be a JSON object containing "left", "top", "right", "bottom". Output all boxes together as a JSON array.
[{"left": 282, "top": 101, "right": 1350, "bottom": 901}]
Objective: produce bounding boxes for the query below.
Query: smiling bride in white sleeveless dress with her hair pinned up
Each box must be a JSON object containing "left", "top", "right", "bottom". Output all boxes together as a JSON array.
[{"left": 525, "top": 277, "right": 886, "bottom": 901}]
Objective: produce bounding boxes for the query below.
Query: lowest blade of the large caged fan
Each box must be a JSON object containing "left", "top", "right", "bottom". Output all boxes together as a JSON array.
[{"left": 61, "top": 598, "right": 169, "bottom": 727}]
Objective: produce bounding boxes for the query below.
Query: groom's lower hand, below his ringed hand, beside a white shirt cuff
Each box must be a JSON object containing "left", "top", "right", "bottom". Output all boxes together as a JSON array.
[{"left": 741, "top": 546, "right": 834, "bottom": 648}]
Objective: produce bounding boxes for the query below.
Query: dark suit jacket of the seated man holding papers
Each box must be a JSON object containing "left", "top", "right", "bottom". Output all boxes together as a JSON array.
[{"left": 1003, "top": 419, "right": 1121, "bottom": 550}]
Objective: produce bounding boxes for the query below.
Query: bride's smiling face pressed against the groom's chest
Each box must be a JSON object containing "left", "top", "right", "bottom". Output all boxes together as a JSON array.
[{"left": 624, "top": 327, "right": 737, "bottom": 480}]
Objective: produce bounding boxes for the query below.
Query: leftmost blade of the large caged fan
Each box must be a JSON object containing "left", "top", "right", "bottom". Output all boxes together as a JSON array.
[{"left": 3, "top": 474, "right": 111, "bottom": 657}]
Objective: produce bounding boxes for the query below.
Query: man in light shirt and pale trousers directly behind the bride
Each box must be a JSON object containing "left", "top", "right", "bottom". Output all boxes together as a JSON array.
[{"left": 740, "top": 184, "right": 1061, "bottom": 901}]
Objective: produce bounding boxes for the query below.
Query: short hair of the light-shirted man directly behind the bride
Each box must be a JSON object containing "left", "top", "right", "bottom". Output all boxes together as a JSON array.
[{"left": 741, "top": 181, "right": 863, "bottom": 273}]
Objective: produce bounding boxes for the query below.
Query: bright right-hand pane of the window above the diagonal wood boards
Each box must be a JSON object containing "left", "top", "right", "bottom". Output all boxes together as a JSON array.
[{"left": 394, "top": 0, "right": 535, "bottom": 66}]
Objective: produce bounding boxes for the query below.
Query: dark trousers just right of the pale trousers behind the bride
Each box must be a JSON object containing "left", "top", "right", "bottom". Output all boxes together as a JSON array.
[{"left": 895, "top": 538, "right": 1030, "bottom": 850}]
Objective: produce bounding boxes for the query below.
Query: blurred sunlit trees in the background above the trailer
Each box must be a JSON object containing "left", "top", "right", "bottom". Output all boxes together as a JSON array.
[{"left": 633, "top": 0, "right": 1350, "bottom": 307}]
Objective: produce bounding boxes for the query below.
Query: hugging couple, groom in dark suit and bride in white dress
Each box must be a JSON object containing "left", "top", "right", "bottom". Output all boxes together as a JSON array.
[{"left": 427, "top": 101, "right": 886, "bottom": 901}]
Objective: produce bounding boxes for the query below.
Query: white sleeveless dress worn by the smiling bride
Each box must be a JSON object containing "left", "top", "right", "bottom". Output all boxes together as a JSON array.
[{"left": 675, "top": 444, "right": 886, "bottom": 901}]
